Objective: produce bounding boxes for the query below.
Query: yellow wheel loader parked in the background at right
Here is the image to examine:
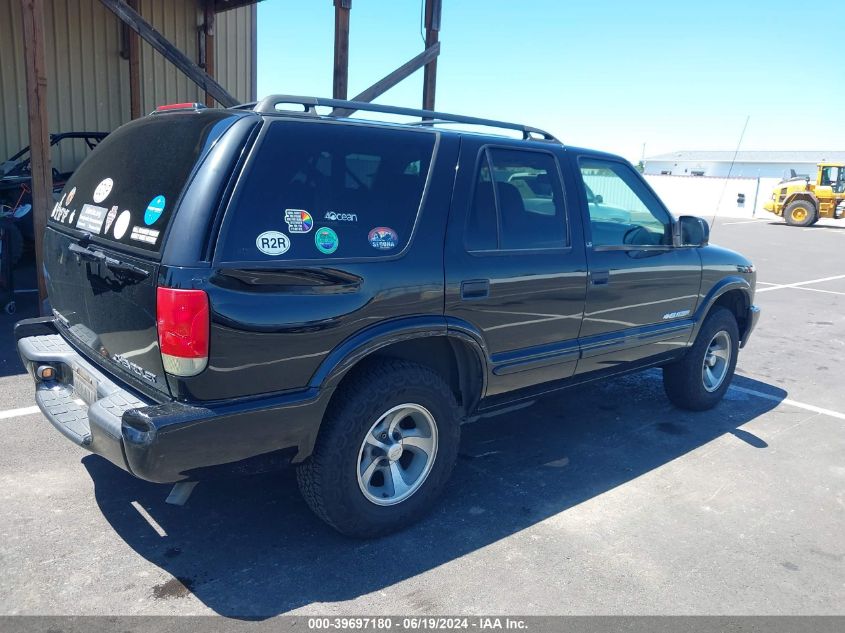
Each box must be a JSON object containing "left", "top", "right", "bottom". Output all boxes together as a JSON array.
[{"left": 763, "top": 163, "right": 845, "bottom": 226}]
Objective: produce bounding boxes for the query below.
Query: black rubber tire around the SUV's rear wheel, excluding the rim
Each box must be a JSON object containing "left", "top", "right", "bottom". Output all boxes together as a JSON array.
[{"left": 296, "top": 359, "right": 460, "bottom": 538}]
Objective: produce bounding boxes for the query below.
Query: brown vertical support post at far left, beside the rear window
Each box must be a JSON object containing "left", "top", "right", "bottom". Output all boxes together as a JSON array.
[{"left": 21, "top": 0, "right": 53, "bottom": 310}]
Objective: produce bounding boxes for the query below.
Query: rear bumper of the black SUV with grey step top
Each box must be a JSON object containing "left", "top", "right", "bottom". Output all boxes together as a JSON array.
[{"left": 15, "top": 319, "right": 328, "bottom": 483}]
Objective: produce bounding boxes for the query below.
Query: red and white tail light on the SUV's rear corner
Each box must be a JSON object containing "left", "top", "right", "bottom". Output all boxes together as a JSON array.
[{"left": 156, "top": 287, "right": 209, "bottom": 376}]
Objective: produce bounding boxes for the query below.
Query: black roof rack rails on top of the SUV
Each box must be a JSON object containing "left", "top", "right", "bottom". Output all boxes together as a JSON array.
[{"left": 233, "top": 95, "right": 560, "bottom": 143}]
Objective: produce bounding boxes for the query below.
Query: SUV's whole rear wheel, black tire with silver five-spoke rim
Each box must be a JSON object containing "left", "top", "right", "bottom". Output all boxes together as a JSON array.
[{"left": 297, "top": 360, "right": 460, "bottom": 538}]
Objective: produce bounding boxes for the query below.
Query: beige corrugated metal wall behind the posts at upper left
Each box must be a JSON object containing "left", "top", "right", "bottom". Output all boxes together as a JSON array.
[{"left": 0, "top": 0, "right": 256, "bottom": 170}]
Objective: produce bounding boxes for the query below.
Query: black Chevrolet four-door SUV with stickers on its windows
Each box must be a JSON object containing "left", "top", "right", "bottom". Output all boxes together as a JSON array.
[{"left": 15, "top": 95, "right": 759, "bottom": 536}]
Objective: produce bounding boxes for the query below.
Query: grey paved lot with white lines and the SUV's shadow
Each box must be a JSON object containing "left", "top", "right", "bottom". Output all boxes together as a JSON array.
[{"left": 0, "top": 220, "right": 845, "bottom": 617}]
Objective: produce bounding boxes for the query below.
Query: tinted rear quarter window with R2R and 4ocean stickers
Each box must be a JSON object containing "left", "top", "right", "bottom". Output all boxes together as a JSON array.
[{"left": 219, "top": 121, "right": 435, "bottom": 261}]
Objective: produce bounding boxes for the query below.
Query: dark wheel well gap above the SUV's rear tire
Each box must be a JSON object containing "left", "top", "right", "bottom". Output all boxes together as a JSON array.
[{"left": 335, "top": 336, "right": 484, "bottom": 415}]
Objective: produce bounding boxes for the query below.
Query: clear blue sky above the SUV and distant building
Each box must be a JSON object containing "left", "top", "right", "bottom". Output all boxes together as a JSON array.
[{"left": 258, "top": 0, "right": 845, "bottom": 162}]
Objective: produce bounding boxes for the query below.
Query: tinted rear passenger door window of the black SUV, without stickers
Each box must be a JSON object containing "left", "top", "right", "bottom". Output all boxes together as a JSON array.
[{"left": 466, "top": 148, "right": 568, "bottom": 251}]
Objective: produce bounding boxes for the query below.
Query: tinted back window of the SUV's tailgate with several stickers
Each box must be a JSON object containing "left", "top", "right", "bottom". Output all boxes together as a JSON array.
[{"left": 48, "top": 112, "right": 234, "bottom": 251}]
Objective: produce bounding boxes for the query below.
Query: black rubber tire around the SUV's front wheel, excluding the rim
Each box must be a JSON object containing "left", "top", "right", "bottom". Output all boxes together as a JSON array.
[{"left": 663, "top": 308, "right": 739, "bottom": 411}]
